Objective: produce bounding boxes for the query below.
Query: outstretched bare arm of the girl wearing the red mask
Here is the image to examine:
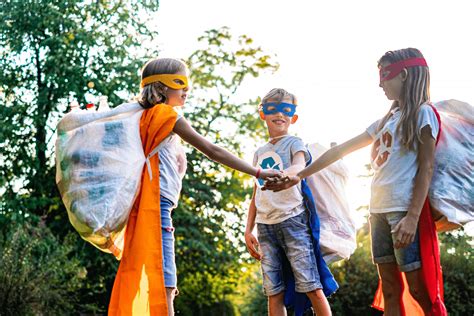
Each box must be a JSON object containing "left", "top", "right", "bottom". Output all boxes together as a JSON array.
[{"left": 263, "top": 132, "right": 372, "bottom": 191}]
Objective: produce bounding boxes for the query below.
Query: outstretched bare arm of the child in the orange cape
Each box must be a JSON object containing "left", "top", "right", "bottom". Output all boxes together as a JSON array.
[{"left": 173, "top": 118, "right": 280, "bottom": 179}]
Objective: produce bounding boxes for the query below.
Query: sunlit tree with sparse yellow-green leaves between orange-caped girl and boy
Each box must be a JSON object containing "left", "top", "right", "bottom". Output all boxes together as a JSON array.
[{"left": 173, "top": 28, "right": 278, "bottom": 315}]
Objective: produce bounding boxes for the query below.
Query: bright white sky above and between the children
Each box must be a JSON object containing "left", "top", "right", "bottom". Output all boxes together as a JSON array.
[{"left": 155, "top": 0, "right": 474, "bottom": 231}]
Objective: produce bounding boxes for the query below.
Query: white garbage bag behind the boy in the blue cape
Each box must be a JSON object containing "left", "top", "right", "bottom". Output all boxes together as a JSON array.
[{"left": 307, "top": 144, "right": 357, "bottom": 264}]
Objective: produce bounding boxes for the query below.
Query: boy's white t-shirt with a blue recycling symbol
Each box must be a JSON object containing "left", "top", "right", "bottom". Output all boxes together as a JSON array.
[{"left": 253, "top": 135, "right": 310, "bottom": 224}]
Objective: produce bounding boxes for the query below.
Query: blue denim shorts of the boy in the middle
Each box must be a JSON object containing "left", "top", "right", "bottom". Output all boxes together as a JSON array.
[{"left": 257, "top": 211, "right": 322, "bottom": 296}]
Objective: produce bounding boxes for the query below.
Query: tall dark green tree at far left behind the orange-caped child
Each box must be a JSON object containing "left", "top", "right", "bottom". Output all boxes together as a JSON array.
[{"left": 0, "top": 0, "right": 158, "bottom": 314}]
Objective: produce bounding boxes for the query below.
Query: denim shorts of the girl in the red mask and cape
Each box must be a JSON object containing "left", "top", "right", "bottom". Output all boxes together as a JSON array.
[{"left": 369, "top": 212, "right": 421, "bottom": 272}]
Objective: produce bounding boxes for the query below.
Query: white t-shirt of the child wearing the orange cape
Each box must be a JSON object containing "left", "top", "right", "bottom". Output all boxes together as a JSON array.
[{"left": 158, "top": 115, "right": 187, "bottom": 207}]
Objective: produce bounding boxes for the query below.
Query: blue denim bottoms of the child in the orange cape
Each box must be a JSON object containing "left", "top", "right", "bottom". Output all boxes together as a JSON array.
[{"left": 160, "top": 196, "right": 177, "bottom": 288}]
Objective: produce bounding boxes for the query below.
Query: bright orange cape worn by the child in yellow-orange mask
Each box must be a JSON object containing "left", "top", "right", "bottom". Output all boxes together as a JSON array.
[{"left": 109, "top": 104, "right": 177, "bottom": 316}]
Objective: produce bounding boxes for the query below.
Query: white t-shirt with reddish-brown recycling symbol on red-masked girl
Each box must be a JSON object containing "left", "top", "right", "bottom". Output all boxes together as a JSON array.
[{"left": 367, "top": 104, "right": 439, "bottom": 213}]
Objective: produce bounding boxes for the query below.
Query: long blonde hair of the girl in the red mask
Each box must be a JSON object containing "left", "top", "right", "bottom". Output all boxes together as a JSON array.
[{"left": 378, "top": 48, "right": 430, "bottom": 150}]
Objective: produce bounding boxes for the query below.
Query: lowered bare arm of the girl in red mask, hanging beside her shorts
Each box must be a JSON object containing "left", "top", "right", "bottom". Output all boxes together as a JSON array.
[{"left": 393, "top": 126, "right": 436, "bottom": 248}]
